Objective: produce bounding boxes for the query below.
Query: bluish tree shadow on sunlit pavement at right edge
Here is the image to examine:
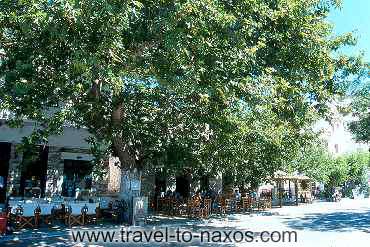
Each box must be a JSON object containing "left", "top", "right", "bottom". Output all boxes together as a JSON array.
[{"left": 284, "top": 211, "right": 370, "bottom": 232}]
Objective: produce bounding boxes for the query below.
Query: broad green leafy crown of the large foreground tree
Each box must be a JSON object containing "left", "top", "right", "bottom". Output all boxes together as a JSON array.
[{"left": 0, "top": 0, "right": 361, "bottom": 185}]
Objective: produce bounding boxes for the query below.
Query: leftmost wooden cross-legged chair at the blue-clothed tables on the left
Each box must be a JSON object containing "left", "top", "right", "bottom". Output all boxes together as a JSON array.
[{"left": 16, "top": 203, "right": 40, "bottom": 229}]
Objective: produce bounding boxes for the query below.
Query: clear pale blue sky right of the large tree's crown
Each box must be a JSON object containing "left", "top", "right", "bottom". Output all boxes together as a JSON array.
[{"left": 329, "top": 0, "right": 370, "bottom": 62}]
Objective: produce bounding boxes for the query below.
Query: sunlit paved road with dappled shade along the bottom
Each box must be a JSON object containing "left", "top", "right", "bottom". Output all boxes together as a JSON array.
[{"left": 0, "top": 199, "right": 370, "bottom": 247}]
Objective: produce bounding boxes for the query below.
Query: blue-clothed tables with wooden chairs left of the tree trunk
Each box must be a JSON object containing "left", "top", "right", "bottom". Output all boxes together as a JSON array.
[{"left": 7, "top": 197, "right": 125, "bottom": 229}]
